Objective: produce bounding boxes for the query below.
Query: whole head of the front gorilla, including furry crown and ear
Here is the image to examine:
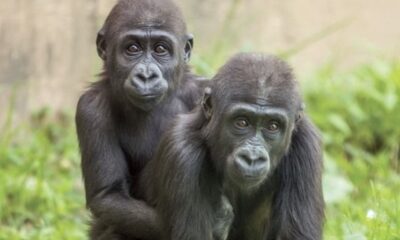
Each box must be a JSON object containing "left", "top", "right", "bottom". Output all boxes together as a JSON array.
[{"left": 203, "top": 54, "right": 300, "bottom": 190}]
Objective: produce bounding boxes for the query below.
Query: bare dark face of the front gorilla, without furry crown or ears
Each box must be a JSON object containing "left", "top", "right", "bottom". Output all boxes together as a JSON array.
[{"left": 221, "top": 103, "right": 293, "bottom": 188}]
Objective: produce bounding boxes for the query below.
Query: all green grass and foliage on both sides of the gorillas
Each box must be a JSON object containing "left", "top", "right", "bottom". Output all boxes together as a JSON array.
[{"left": 0, "top": 61, "right": 400, "bottom": 240}]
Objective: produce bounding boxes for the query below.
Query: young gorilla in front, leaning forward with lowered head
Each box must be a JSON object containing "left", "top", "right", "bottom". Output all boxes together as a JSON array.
[{"left": 140, "top": 54, "right": 324, "bottom": 240}]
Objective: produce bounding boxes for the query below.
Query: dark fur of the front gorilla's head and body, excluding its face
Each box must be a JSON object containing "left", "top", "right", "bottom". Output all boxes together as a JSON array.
[{"left": 141, "top": 54, "right": 324, "bottom": 240}]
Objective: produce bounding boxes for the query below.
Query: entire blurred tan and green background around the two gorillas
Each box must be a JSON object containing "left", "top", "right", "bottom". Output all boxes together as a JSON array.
[{"left": 0, "top": 0, "right": 400, "bottom": 240}]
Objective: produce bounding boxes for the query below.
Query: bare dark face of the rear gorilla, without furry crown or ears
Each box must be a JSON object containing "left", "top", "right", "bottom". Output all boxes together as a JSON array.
[{"left": 115, "top": 27, "right": 183, "bottom": 109}]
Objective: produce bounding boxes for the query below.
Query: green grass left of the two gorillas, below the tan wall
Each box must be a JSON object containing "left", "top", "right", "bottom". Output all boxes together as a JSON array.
[{"left": 0, "top": 111, "right": 88, "bottom": 240}]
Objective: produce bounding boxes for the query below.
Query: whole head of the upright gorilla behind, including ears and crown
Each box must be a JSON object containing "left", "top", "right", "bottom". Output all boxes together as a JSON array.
[{"left": 97, "top": 1, "right": 193, "bottom": 111}]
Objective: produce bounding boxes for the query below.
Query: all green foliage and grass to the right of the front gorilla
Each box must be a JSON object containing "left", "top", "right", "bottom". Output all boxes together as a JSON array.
[{"left": 301, "top": 61, "right": 400, "bottom": 239}]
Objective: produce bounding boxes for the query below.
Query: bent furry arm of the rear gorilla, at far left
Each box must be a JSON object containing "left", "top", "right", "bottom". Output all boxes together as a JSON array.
[{"left": 76, "top": 92, "right": 161, "bottom": 239}]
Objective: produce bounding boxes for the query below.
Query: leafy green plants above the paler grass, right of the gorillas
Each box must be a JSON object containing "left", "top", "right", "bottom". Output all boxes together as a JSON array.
[{"left": 302, "top": 62, "right": 400, "bottom": 161}]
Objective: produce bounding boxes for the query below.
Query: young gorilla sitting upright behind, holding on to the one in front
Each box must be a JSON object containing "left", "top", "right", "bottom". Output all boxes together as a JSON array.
[{"left": 76, "top": 0, "right": 204, "bottom": 240}]
